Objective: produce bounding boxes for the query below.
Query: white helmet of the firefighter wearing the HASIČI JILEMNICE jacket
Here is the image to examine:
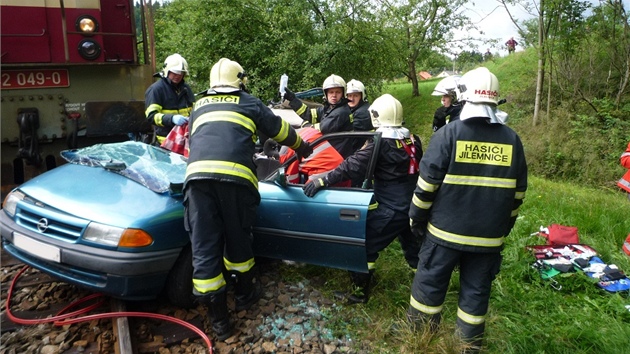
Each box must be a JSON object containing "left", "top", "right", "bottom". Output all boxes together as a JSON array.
[{"left": 458, "top": 67, "right": 499, "bottom": 106}]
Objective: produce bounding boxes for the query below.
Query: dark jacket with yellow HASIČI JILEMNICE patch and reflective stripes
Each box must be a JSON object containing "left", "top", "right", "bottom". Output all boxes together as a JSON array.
[{"left": 409, "top": 118, "right": 527, "bottom": 252}]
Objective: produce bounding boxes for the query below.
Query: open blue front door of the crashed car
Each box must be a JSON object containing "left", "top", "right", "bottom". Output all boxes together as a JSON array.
[{"left": 254, "top": 132, "right": 380, "bottom": 272}]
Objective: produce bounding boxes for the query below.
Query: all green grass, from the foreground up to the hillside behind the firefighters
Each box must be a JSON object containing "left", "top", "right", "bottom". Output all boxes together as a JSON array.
[{"left": 284, "top": 58, "right": 630, "bottom": 354}]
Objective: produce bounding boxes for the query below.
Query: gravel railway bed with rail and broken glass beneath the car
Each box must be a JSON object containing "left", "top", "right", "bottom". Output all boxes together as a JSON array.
[{"left": 0, "top": 252, "right": 371, "bottom": 354}]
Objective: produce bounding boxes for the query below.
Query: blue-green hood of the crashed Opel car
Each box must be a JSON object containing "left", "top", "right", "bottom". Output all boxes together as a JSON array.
[{"left": 19, "top": 143, "right": 185, "bottom": 227}]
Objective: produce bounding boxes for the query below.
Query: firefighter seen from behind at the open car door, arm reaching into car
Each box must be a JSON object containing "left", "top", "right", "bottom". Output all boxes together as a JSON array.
[{"left": 303, "top": 94, "right": 422, "bottom": 304}]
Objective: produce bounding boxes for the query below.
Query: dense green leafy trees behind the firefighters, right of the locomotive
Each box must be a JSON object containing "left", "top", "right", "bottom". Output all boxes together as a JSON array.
[{"left": 155, "top": 0, "right": 394, "bottom": 99}]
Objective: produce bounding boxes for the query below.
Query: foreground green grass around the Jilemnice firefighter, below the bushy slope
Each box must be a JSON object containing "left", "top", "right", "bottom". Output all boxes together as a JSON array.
[{"left": 284, "top": 177, "right": 630, "bottom": 354}]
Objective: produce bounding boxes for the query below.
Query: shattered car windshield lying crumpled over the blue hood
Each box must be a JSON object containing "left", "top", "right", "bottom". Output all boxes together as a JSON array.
[{"left": 61, "top": 141, "right": 186, "bottom": 193}]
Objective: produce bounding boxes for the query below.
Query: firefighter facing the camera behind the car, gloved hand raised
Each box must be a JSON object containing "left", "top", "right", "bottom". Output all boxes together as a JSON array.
[{"left": 283, "top": 74, "right": 354, "bottom": 158}]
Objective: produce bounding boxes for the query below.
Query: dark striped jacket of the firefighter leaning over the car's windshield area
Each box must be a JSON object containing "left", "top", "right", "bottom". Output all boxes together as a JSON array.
[{"left": 186, "top": 91, "right": 302, "bottom": 198}]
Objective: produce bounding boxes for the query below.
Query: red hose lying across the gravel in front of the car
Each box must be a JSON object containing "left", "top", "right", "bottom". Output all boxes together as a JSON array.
[{"left": 6, "top": 266, "right": 213, "bottom": 354}]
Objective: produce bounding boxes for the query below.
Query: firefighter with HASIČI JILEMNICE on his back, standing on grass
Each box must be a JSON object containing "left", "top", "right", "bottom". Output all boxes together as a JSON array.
[{"left": 407, "top": 67, "right": 527, "bottom": 352}]
